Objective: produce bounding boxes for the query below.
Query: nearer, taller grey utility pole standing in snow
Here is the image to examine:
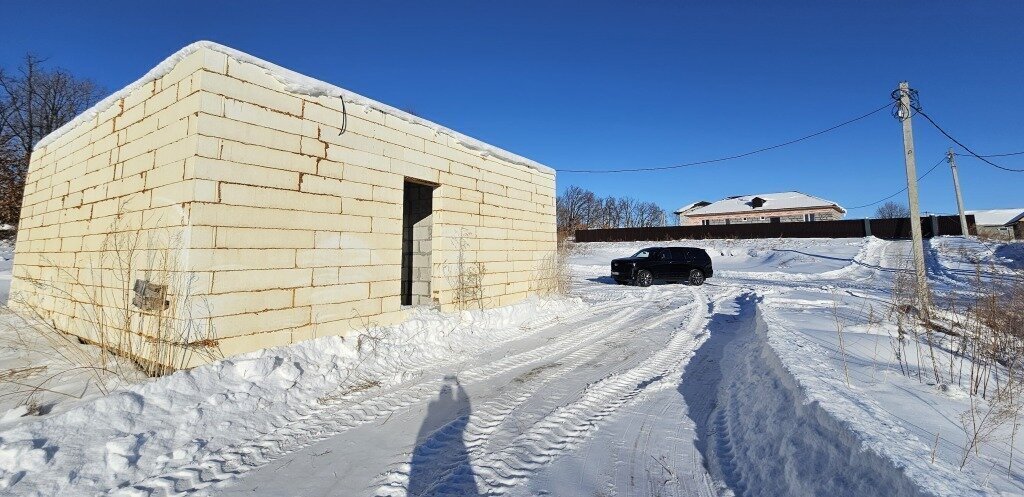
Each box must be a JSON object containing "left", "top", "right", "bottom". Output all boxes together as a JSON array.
[{"left": 897, "top": 81, "right": 931, "bottom": 313}]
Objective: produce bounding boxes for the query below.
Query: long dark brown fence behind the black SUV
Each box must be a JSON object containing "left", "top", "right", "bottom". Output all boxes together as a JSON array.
[{"left": 575, "top": 215, "right": 977, "bottom": 242}]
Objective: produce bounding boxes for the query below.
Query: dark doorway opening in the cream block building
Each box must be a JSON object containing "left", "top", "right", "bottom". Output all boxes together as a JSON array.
[{"left": 401, "top": 179, "right": 437, "bottom": 305}]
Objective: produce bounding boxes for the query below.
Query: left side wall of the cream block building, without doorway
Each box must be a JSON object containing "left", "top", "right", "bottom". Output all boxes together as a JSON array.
[{"left": 10, "top": 53, "right": 220, "bottom": 365}]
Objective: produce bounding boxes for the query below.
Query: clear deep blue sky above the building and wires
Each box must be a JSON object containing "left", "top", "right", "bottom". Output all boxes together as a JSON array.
[{"left": 0, "top": 0, "right": 1024, "bottom": 216}]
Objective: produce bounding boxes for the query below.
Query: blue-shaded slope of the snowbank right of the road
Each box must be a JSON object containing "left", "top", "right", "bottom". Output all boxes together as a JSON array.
[{"left": 680, "top": 295, "right": 962, "bottom": 497}]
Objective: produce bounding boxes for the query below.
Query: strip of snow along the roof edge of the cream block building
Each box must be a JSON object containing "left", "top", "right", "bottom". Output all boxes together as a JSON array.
[{"left": 36, "top": 41, "right": 555, "bottom": 174}]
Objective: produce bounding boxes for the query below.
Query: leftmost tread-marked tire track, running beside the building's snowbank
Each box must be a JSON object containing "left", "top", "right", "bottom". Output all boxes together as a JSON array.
[{"left": 116, "top": 292, "right": 671, "bottom": 496}]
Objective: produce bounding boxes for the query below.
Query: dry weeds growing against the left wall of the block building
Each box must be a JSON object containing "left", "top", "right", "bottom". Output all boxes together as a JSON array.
[{"left": 10, "top": 209, "right": 220, "bottom": 395}]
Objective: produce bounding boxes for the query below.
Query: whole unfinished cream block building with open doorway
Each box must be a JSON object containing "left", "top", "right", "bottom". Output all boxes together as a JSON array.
[{"left": 11, "top": 42, "right": 556, "bottom": 367}]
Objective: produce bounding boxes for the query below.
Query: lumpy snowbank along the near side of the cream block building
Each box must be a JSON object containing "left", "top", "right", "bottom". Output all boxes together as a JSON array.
[{"left": 0, "top": 299, "right": 582, "bottom": 495}]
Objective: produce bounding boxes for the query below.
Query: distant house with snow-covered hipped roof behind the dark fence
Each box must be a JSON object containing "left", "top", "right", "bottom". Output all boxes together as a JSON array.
[{"left": 676, "top": 192, "right": 846, "bottom": 225}]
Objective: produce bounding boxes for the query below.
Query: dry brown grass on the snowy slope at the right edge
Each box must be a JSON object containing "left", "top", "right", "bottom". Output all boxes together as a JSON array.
[{"left": 891, "top": 243, "right": 1024, "bottom": 469}]
